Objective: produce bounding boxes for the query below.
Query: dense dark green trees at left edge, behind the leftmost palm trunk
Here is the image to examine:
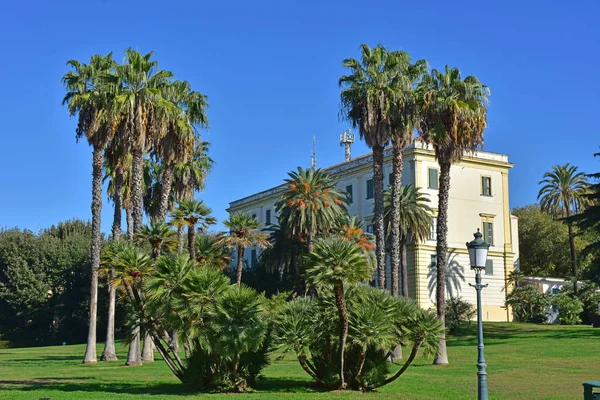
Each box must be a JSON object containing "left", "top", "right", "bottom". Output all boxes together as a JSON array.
[{"left": 0, "top": 220, "right": 106, "bottom": 345}]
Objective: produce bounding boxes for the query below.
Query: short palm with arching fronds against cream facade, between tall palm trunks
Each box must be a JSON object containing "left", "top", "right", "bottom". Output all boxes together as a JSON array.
[{"left": 384, "top": 185, "right": 432, "bottom": 297}]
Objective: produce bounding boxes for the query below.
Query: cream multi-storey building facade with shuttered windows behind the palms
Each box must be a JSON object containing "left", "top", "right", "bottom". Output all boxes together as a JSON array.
[{"left": 228, "top": 141, "right": 519, "bottom": 321}]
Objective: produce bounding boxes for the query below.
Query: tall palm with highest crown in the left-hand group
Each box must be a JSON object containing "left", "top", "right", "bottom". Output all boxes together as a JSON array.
[{"left": 112, "top": 48, "right": 175, "bottom": 233}]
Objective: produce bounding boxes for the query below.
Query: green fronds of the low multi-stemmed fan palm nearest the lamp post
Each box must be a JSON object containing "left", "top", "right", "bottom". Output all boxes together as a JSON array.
[{"left": 275, "top": 285, "right": 442, "bottom": 390}]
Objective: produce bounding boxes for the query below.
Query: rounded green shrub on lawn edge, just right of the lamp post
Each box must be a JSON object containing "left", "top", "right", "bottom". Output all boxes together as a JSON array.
[{"left": 506, "top": 286, "right": 550, "bottom": 323}]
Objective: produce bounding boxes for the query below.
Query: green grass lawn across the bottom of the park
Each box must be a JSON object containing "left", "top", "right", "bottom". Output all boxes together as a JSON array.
[{"left": 0, "top": 323, "right": 600, "bottom": 400}]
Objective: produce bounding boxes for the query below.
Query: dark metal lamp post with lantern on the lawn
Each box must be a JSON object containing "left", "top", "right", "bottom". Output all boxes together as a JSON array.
[{"left": 467, "top": 229, "right": 490, "bottom": 400}]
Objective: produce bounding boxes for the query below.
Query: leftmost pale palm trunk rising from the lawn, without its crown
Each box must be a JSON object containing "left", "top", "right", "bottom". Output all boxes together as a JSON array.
[{"left": 83, "top": 147, "right": 103, "bottom": 364}]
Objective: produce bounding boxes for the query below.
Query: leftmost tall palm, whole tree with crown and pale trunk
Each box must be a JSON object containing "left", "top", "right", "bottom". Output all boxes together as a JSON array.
[{"left": 62, "top": 53, "right": 115, "bottom": 363}]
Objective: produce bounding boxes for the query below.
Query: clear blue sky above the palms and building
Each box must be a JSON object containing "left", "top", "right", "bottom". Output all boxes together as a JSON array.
[{"left": 0, "top": 0, "right": 600, "bottom": 231}]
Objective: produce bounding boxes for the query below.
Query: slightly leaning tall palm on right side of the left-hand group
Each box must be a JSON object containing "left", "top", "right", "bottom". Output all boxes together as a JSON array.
[{"left": 157, "top": 81, "right": 208, "bottom": 220}]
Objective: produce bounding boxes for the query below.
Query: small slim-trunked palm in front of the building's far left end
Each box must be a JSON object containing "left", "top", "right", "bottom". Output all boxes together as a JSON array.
[{"left": 220, "top": 214, "right": 270, "bottom": 285}]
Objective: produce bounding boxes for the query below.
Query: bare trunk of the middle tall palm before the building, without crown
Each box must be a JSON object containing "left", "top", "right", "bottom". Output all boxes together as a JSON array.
[{"left": 390, "top": 138, "right": 403, "bottom": 296}]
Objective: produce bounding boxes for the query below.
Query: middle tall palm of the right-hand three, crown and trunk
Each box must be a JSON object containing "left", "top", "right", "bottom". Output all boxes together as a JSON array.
[{"left": 384, "top": 57, "right": 428, "bottom": 296}]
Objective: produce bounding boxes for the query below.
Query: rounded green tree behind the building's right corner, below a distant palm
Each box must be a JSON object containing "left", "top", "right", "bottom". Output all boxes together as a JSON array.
[{"left": 512, "top": 204, "right": 590, "bottom": 278}]
